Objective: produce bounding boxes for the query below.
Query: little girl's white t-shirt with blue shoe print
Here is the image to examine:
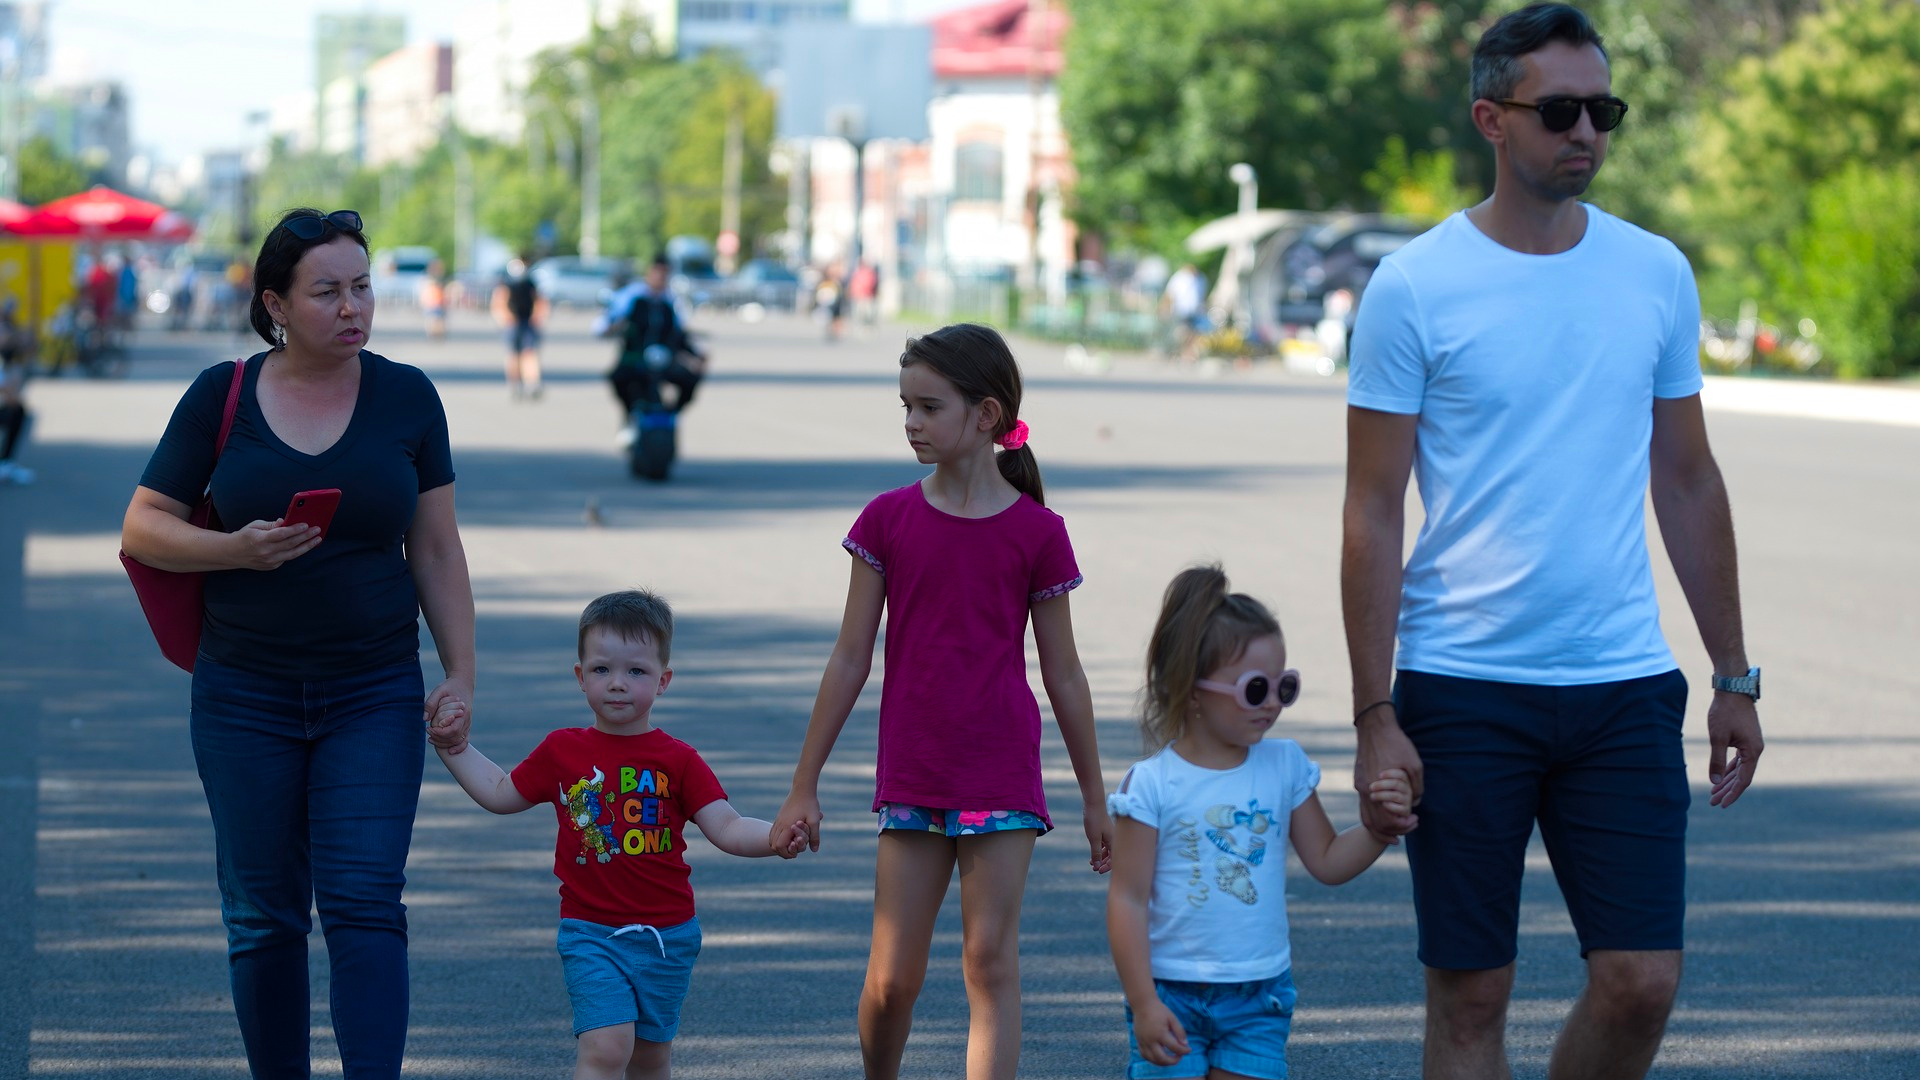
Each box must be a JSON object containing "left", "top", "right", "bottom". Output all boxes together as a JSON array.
[{"left": 1106, "top": 738, "right": 1319, "bottom": 982}]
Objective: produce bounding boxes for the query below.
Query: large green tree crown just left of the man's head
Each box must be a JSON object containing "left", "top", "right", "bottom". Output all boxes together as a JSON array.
[{"left": 1060, "top": 0, "right": 1480, "bottom": 252}]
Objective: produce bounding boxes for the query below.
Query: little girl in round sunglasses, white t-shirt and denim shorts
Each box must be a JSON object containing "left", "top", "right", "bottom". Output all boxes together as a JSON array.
[{"left": 1106, "top": 567, "right": 1413, "bottom": 1080}]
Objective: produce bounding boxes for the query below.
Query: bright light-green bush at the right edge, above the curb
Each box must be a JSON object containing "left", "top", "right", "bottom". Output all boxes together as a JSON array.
[{"left": 1770, "top": 163, "right": 1920, "bottom": 379}]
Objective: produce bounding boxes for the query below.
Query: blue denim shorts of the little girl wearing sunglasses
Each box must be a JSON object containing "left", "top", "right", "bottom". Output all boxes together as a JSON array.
[{"left": 1127, "top": 970, "right": 1300, "bottom": 1080}]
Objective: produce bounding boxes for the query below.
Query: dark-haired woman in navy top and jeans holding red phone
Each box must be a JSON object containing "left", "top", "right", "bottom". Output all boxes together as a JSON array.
[{"left": 121, "top": 209, "right": 474, "bottom": 1080}]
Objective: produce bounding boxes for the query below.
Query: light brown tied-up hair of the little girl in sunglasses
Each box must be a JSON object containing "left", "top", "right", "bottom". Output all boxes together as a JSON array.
[{"left": 1140, "top": 563, "right": 1281, "bottom": 753}]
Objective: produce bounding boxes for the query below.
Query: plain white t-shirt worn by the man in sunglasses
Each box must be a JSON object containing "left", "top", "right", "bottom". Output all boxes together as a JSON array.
[{"left": 1346, "top": 206, "right": 1701, "bottom": 686}]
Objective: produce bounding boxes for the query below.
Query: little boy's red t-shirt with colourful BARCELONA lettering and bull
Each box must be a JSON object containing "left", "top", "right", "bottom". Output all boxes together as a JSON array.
[{"left": 513, "top": 728, "right": 726, "bottom": 926}]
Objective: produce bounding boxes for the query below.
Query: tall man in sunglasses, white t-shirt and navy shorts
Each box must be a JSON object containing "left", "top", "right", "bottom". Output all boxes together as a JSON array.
[{"left": 1342, "top": 4, "right": 1763, "bottom": 1080}]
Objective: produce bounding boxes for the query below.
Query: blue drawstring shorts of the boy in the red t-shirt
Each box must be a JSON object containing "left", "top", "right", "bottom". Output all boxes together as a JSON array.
[{"left": 557, "top": 919, "right": 701, "bottom": 1042}]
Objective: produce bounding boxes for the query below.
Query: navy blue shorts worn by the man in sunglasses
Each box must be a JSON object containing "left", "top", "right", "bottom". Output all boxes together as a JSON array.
[{"left": 1394, "top": 671, "right": 1692, "bottom": 970}]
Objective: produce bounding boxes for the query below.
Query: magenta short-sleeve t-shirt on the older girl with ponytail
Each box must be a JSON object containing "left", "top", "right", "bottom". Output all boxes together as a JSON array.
[{"left": 843, "top": 484, "right": 1081, "bottom": 824}]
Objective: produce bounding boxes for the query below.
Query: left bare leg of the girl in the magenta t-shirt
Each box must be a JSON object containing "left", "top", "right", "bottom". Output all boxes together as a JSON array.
[{"left": 860, "top": 828, "right": 954, "bottom": 1080}]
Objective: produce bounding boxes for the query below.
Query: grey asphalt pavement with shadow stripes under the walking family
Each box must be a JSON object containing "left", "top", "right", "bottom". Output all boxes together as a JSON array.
[{"left": 0, "top": 311, "right": 1920, "bottom": 1080}]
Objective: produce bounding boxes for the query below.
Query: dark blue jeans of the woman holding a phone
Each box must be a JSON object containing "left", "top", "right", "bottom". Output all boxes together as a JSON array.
[{"left": 192, "top": 655, "right": 426, "bottom": 1080}]
